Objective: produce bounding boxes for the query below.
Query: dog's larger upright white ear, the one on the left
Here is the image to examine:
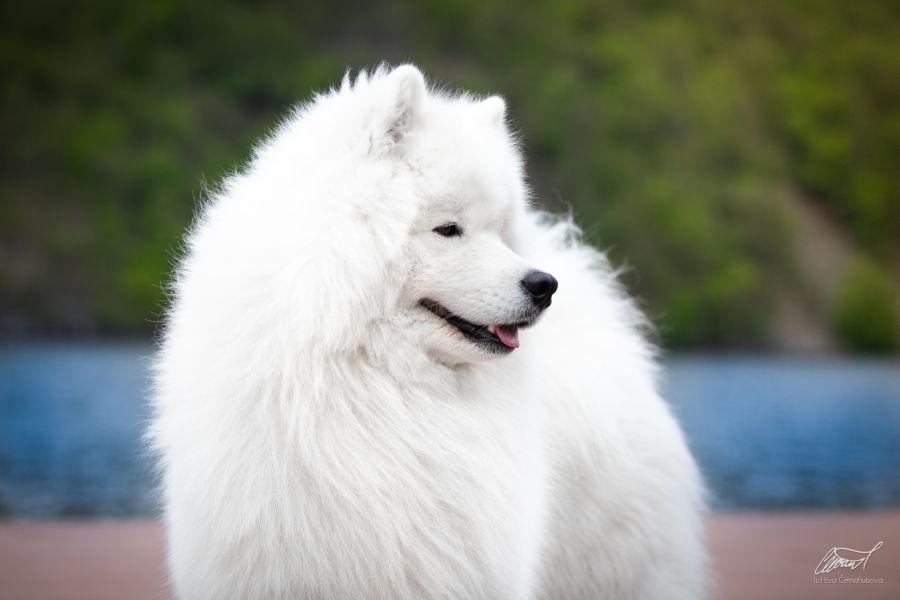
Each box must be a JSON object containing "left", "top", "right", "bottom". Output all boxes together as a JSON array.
[{"left": 372, "top": 65, "right": 426, "bottom": 152}]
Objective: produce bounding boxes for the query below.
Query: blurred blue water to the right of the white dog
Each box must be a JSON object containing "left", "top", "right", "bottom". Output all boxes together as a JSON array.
[{"left": 665, "top": 357, "right": 900, "bottom": 509}]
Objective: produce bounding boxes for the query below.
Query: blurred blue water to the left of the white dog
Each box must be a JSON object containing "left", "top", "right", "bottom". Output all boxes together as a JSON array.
[{"left": 0, "top": 344, "right": 154, "bottom": 517}]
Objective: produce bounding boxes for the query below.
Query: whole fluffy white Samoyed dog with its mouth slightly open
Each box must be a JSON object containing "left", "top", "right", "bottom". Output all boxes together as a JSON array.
[{"left": 150, "top": 65, "right": 707, "bottom": 600}]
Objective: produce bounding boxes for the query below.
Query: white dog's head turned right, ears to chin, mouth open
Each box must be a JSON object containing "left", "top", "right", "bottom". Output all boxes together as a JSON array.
[{"left": 374, "top": 66, "right": 557, "bottom": 363}]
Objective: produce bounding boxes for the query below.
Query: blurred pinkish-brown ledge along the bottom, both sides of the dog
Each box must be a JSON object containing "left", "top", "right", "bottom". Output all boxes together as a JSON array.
[{"left": 0, "top": 511, "right": 900, "bottom": 600}]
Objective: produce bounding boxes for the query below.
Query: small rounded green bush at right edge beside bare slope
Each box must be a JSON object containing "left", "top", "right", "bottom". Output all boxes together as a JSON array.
[{"left": 834, "top": 261, "right": 900, "bottom": 352}]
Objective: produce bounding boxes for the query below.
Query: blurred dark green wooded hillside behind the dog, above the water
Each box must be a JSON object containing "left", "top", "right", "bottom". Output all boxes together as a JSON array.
[{"left": 0, "top": 0, "right": 900, "bottom": 350}]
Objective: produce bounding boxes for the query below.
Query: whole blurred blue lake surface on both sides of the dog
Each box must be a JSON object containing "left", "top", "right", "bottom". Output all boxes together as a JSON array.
[{"left": 0, "top": 343, "right": 900, "bottom": 518}]
